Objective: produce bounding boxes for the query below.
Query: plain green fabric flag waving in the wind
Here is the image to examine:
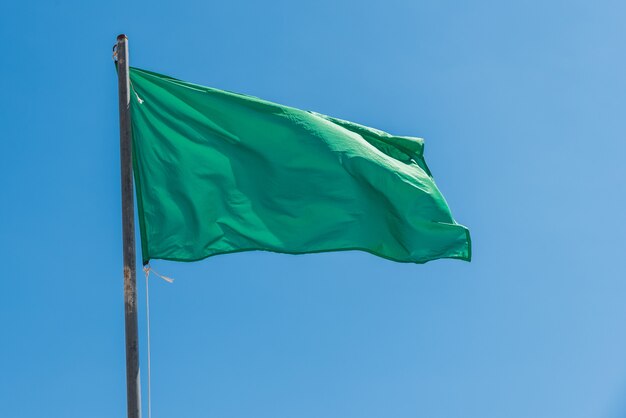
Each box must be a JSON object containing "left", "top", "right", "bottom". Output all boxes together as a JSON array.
[{"left": 130, "top": 68, "right": 470, "bottom": 263}]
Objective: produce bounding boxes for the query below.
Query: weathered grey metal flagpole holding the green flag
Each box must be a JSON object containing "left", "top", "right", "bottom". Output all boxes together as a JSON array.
[{"left": 116, "top": 34, "right": 141, "bottom": 418}]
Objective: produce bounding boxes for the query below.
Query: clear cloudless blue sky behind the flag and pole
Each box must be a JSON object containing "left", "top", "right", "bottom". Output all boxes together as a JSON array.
[{"left": 0, "top": 0, "right": 626, "bottom": 418}]
